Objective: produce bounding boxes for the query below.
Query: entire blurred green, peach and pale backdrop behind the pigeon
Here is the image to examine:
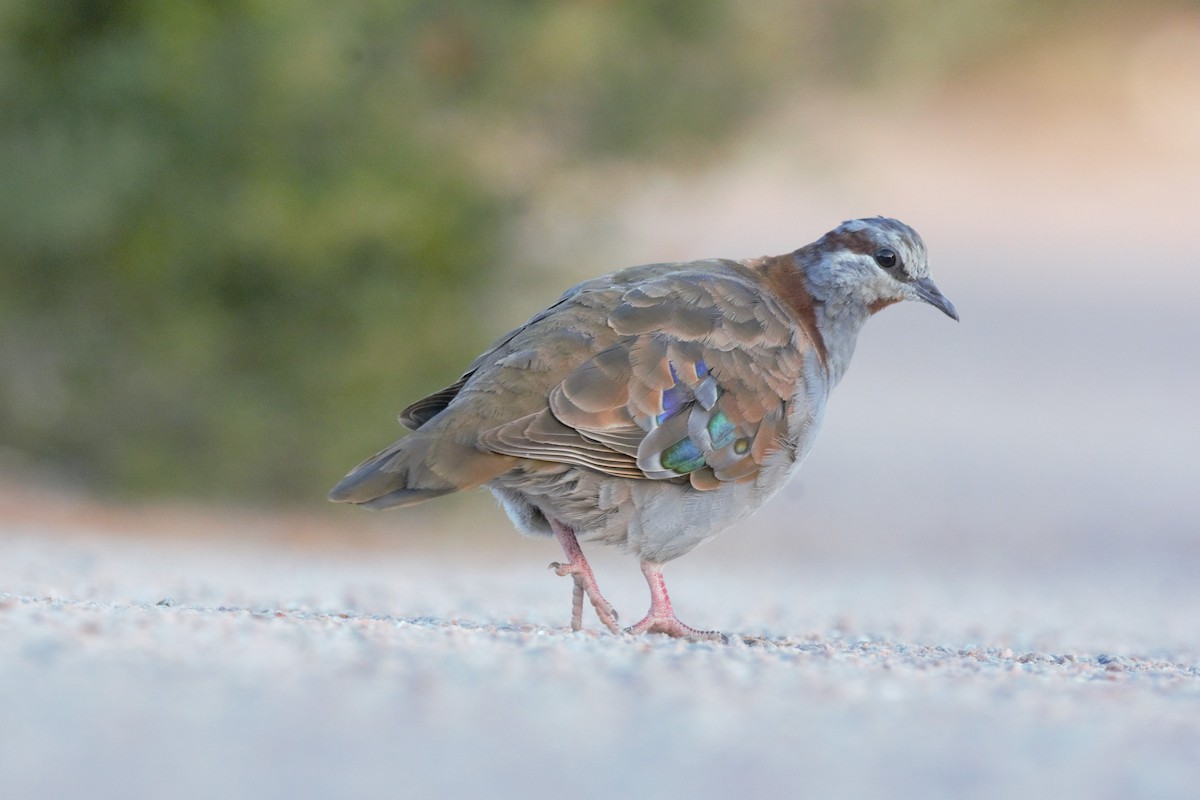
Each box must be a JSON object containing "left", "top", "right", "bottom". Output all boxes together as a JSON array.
[{"left": 0, "top": 0, "right": 1200, "bottom": 573}]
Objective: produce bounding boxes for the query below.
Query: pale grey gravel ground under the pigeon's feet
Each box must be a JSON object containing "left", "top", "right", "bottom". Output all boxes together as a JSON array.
[{"left": 0, "top": 494, "right": 1200, "bottom": 799}]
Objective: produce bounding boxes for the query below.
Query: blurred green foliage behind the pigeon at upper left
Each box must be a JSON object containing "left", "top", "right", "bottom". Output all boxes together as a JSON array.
[{"left": 0, "top": 0, "right": 1123, "bottom": 499}]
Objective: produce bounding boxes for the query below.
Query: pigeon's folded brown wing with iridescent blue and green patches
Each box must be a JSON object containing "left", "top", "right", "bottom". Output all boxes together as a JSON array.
[{"left": 478, "top": 268, "right": 818, "bottom": 489}]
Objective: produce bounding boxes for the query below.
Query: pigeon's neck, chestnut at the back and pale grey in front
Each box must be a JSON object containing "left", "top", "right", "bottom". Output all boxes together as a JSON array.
[{"left": 748, "top": 251, "right": 875, "bottom": 386}]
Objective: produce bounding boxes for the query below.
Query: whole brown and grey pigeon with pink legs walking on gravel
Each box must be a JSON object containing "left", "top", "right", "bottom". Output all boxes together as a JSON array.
[{"left": 329, "top": 217, "right": 959, "bottom": 639}]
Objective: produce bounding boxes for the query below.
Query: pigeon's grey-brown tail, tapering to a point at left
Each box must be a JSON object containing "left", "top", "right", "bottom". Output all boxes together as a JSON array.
[{"left": 329, "top": 432, "right": 512, "bottom": 509}]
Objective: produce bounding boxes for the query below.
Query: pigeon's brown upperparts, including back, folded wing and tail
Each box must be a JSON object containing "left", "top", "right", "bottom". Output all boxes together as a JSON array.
[{"left": 331, "top": 258, "right": 823, "bottom": 507}]
